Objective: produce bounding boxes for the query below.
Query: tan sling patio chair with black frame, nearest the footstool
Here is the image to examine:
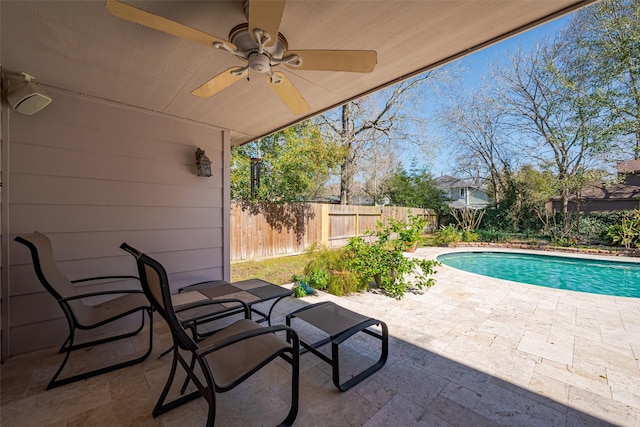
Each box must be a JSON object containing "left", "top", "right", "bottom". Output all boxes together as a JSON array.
[{"left": 120, "top": 243, "right": 300, "bottom": 427}]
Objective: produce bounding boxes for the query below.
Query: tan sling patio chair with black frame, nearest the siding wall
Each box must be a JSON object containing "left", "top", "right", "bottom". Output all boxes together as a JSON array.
[{"left": 14, "top": 232, "right": 153, "bottom": 390}]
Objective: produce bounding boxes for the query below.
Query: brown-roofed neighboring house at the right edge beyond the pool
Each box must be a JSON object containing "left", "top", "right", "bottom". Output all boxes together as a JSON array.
[{"left": 547, "top": 160, "right": 640, "bottom": 213}]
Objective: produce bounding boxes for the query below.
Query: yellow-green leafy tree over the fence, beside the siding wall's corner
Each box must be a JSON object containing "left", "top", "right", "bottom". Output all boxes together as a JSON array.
[{"left": 231, "top": 121, "right": 344, "bottom": 203}]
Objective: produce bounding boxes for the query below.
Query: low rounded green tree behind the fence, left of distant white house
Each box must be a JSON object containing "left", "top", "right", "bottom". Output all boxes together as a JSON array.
[{"left": 383, "top": 167, "right": 447, "bottom": 212}]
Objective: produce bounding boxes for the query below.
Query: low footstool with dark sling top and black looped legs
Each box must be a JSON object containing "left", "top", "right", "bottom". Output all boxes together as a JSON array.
[{"left": 286, "top": 302, "right": 389, "bottom": 391}]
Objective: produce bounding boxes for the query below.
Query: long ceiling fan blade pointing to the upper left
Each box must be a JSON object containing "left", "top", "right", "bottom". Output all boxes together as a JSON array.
[{"left": 105, "top": 0, "right": 236, "bottom": 50}]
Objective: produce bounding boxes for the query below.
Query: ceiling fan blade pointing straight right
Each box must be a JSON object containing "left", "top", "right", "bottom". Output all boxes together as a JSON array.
[{"left": 286, "top": 50, "right": 378, "bottom": 73}]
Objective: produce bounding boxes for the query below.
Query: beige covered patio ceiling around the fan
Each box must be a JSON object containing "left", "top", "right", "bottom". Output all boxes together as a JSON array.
[{"left": 0, "top": 0, "right": 592, "bottom": 144}]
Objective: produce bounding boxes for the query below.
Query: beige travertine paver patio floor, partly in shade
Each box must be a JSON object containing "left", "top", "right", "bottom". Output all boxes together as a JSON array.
[{"left": 0, "top": 248, "right": 640, "bottom": 427}]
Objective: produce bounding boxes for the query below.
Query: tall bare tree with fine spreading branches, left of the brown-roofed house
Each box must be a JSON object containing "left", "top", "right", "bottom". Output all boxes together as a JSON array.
[{"left": 493, "top": 39, "right": 602, "bottom": 211}]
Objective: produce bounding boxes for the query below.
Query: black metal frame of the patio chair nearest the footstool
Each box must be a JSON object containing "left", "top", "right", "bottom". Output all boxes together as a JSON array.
[{"left": 120, "top": 243, "right": 300, "bottom": 427}]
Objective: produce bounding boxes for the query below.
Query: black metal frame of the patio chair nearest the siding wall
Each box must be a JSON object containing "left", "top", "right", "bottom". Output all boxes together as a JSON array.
[{"left": 14, "top": 233, "right": 153, "bottom": 390}]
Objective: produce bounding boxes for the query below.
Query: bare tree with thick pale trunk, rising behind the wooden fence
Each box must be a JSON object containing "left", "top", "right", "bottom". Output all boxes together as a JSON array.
[{"left": 317, "top": 69, "right": 447, "bottom": 204}]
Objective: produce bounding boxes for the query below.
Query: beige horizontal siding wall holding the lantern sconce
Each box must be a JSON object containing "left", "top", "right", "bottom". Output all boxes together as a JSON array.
[{"left": 2, "top": 88, "right": 229, "bottom": 357}]
